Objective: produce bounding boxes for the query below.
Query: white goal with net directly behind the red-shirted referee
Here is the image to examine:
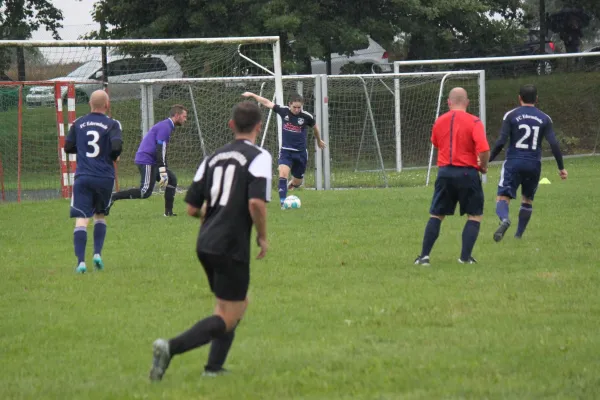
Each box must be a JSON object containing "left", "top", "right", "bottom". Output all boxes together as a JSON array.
[{"left": 324, "top": 71, "right": 485, "bottom": 188}]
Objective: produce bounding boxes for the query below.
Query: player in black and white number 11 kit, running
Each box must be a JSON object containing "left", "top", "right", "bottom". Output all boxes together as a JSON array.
[{"left": 150, "top": 101, "right": 272, "bottom": 381}]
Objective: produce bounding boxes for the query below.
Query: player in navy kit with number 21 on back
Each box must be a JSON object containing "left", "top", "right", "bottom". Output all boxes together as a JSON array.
[{"left": 490, "top": 85, "right": 568, "bottom": 242}]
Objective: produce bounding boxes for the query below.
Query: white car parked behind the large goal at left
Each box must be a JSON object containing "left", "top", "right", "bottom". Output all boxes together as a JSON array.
[{"left": 25, "top": 54, "right": 183, "bottom": 107}]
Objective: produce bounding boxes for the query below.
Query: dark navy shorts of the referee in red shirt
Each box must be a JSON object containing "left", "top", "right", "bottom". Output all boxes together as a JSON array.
[{"left": 429, "top": 166, "right": 483, "bottom": 216}]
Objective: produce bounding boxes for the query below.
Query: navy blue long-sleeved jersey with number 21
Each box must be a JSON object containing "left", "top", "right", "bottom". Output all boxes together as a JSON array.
[{"left": 490, "top": 106, "right": 563, "bottom": 169}]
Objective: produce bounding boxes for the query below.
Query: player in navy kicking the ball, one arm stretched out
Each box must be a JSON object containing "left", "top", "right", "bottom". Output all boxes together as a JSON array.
[{"left": 242, "top": 92, "right": 325, "bottom": 208}]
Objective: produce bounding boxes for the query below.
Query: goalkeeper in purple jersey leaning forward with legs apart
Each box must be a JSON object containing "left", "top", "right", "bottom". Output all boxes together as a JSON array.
[{"left": 110, "top": 104, "right": 187, "bottom": 217}]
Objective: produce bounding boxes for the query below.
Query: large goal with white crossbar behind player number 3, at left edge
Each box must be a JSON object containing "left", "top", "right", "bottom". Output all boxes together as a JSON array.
[{"left": 0, "top": 36, "right": 283, "bottom": 200}]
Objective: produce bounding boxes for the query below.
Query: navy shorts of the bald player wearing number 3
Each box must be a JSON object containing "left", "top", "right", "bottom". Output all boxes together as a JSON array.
[{"left": 71, "top": 175, "right": 115, "bottom": 218}]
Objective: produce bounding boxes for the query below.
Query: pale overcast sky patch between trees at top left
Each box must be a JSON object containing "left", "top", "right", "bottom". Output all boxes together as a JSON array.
[{"left": 33, "top": 0, "right": 98, "bottom": 40}]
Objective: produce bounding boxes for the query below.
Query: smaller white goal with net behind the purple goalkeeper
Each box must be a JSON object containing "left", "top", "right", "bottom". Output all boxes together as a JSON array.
[{"left": 136, "top": 75, "right": 322, "bottom": 192}]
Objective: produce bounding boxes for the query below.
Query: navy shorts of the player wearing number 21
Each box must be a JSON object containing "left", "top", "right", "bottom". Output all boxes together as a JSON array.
[{"left": 498, "top": 160, "right": 542, "bottom": 200}]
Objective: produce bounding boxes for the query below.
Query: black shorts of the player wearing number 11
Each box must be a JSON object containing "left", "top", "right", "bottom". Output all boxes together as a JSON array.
[{"left": 197, "top": 251, "right": 250, "bottom": 301}]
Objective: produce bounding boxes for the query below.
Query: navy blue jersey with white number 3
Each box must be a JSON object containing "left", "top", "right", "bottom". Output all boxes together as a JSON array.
[{"left": 65, "top": 113, "right": 122, "bottom": 179}]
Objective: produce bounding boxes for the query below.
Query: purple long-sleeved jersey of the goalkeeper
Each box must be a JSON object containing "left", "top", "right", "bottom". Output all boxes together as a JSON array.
[{"left": 135, "top": 118, "right": 175, "bottom": 167}]
